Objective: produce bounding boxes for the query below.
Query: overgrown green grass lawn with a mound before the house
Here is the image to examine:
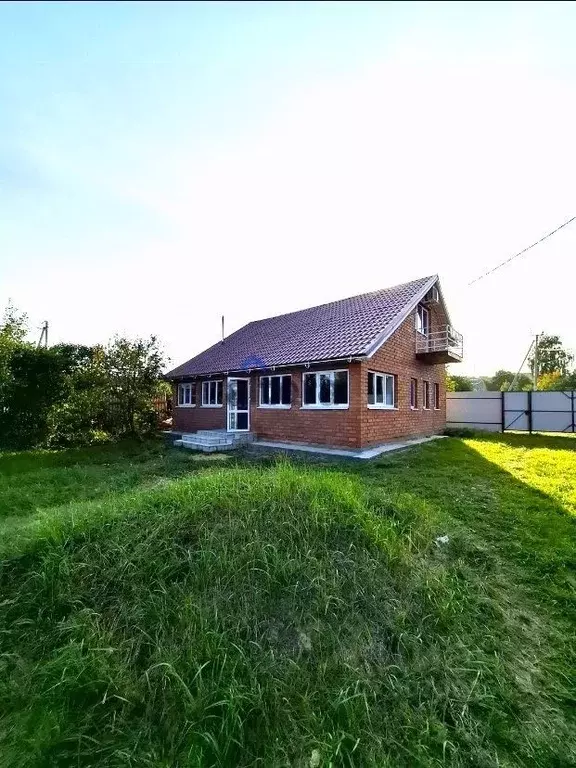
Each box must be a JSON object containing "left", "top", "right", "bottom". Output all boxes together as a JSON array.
[{"left": 0, "top": 435, "right": 576, "bottom": 768}]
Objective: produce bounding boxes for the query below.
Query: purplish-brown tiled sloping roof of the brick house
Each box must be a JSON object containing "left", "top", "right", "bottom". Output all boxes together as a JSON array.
[{"left": 166, "top": 275, "right": 438, "bottom": 379}]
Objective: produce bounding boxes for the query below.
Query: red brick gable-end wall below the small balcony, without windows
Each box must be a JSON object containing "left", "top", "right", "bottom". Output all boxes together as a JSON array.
[{"left": 360, "top": 309, "right": 446, "bottom": 446}]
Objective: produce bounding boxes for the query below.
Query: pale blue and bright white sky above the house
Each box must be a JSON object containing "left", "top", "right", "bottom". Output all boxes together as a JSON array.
[{"left": 0, "top": 2, "right": 576, "bottom": 375}]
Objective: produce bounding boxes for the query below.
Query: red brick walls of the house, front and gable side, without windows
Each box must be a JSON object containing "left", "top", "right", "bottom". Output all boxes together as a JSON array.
[{"left": 173, "top": 307, "right": 446, "bottom": 448}]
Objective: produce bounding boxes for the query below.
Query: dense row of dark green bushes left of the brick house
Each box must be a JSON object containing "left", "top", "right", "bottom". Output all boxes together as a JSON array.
[{"left": 0, "top": 307, "right": 164, "bottom": 448}]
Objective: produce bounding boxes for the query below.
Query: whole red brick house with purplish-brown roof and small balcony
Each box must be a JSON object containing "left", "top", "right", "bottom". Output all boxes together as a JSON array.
[{"left": 167, "top": 275, "right": 462, "bottom": 449}]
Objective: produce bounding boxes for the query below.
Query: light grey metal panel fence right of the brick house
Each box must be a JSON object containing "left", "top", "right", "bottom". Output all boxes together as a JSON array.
[{"left": 446, "top": 390, "right": 576, "bottom": 432}]
